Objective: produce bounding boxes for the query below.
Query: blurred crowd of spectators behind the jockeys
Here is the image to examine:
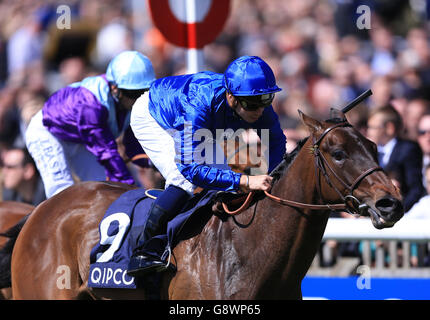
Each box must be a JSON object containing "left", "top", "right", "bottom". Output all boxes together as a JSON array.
[{"left": 0, "top": 0, "right": 430, "bottom": 264}]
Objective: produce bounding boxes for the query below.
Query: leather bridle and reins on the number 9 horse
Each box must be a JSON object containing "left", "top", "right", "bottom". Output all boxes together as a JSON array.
[{"left": 223, "top": 121, "right": 383, "bottom": 215}]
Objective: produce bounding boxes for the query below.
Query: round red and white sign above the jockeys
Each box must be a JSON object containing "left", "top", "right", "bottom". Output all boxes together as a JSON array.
[{"left": 148, "top": 0, "right": 230, "bottom": 49}]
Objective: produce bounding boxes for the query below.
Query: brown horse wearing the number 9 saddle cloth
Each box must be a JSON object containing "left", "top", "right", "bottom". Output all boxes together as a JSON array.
[{"left": 11, "top": 112, "right": 403, "bottom": 299}]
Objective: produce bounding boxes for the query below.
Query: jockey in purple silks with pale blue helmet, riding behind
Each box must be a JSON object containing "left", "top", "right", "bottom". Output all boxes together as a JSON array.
[{"left": 26, "top": 51, "right": 155, "bottom": 198}]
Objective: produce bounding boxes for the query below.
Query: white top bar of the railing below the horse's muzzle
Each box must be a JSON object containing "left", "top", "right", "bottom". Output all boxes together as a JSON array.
[{"left": 323, "top": 219, "right": 430, "bottom": 242}]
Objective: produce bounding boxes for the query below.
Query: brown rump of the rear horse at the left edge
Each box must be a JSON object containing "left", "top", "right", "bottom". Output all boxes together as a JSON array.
[{"left": 0, "top": 201, "right": 34, "bottom": 299}]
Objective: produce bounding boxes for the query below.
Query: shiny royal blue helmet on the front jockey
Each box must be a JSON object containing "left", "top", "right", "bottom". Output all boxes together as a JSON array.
[{"left": 224, "top": 56, "right": 282, "bottom": 96}]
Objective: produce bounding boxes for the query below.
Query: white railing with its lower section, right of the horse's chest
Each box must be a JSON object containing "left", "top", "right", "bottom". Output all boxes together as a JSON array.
[{"left": 309, "top": 219, "right": 430, "bottom": 278}]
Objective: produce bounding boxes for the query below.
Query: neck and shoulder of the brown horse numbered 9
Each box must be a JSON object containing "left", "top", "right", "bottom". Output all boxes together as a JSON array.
[{"left": 178, "top": 151, "right": 328, "bottom": 299}]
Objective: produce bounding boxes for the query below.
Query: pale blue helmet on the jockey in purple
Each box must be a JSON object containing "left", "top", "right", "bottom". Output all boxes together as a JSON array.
[{"left": 106, "top": 51, "right": 155, "bottom": 90}]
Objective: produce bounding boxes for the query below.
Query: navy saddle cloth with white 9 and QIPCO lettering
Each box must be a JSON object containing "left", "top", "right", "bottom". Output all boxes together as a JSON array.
[{"left": 88, "top": 189, "right": 217, "bottom": 289}]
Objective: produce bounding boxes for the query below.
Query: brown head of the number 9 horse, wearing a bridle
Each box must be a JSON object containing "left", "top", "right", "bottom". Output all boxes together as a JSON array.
[{"left": 299, "top": 110, "right": 403, "bottom": 229}]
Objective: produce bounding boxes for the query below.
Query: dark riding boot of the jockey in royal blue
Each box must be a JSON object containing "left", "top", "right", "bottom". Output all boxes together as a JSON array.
[{"left": 127, "top": 186, "right": 189, "bottom": 277}]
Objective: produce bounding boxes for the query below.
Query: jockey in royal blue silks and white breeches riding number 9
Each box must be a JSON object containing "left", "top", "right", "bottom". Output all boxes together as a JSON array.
[{"left": 127, "top": 56, "right": 286, "bottom": 276}]
